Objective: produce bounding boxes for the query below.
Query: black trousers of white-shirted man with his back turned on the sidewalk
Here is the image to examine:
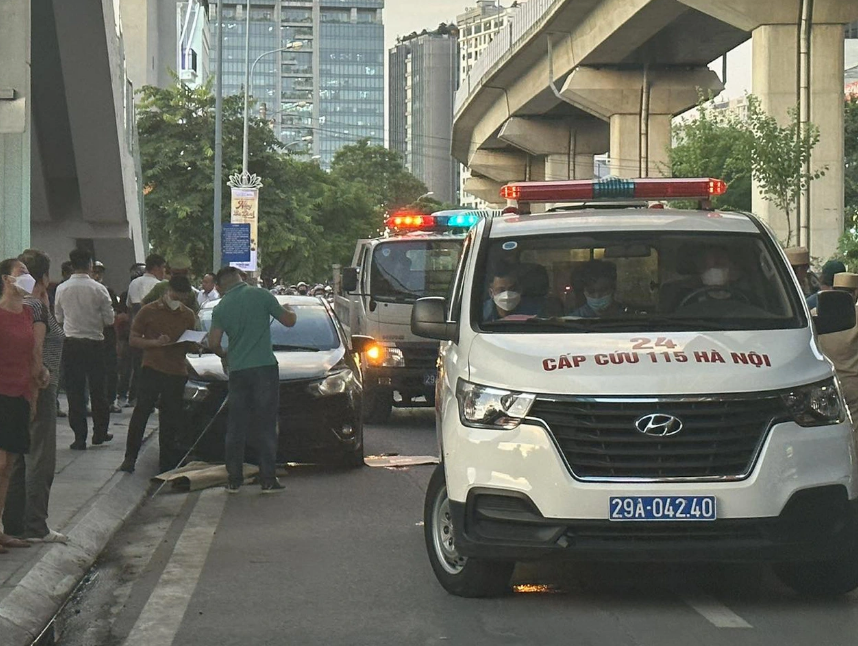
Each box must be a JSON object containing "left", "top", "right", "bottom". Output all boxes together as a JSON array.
[{"left": 63, "top": 338, "right": 110, "bottom": 442}]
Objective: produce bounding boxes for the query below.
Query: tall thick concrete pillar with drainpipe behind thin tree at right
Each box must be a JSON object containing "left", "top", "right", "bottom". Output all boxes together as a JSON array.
[{"left": 752, "top": 24, "right": 844, "bottom": 260}]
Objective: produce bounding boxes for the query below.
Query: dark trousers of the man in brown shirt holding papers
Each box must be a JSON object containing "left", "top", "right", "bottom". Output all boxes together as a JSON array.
[{"left": 125, "top": 366, "right": 188, "bottom": 473}]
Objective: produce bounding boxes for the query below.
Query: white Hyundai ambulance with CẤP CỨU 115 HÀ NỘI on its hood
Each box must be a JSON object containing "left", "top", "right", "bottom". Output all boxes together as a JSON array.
[{"left": 411, "top": 179, "right": 858, "bottom": 596}]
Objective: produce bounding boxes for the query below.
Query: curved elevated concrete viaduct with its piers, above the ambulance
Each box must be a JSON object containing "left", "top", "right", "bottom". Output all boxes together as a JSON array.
[{"left": 452, "top": 0, "right": 858, "bottom": 258}]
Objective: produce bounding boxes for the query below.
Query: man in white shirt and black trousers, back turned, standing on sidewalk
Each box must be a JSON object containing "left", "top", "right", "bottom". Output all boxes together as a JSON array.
[{"left": 54, "top": 249, "right": 114, "bottom": 451}]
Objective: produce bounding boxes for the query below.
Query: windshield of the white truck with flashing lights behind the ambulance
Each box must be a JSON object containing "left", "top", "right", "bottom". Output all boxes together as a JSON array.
[{"left": 370, "top": 238, "right": 462, "bottom": 303}]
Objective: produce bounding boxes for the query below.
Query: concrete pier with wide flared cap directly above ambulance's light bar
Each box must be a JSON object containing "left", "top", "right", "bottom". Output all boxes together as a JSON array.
[{"left": 561, "top": 67, "right": 723, "bottom": 177}]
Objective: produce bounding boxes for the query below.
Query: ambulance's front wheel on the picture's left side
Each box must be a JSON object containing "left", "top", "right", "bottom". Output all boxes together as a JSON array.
[{"left": 423, "top": 465, "right": 515, "bottom": 597}]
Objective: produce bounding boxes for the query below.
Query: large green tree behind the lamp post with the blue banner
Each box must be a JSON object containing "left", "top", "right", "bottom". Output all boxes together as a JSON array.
[{"left": 138, "top": 83, "right": 327, "bottom": 275}]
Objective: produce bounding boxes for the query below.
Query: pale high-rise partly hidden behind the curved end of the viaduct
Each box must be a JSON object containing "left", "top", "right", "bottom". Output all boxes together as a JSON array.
[{"left": 456, "top": 0, "right": 522, "bottom": 208}]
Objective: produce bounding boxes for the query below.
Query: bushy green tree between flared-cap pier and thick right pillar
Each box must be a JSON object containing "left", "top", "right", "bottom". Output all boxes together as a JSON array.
[{"left": 670, "top": 99, "right": 753, "bottom": 211}]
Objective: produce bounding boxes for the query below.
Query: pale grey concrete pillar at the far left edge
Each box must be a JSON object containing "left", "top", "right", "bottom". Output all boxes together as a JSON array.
[{"left": 0, "top": 0, "right": 31, "bottom": 260}]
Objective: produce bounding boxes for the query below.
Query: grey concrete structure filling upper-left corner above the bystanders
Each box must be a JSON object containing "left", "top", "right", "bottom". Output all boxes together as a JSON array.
[{"left": 0, "top": 0, "right": 146, "bottom": 287}]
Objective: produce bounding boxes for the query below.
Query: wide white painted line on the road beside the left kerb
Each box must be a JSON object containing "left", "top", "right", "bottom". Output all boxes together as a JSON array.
[{"left": 124, "top": 489, "right": 226, "bottom": 646}]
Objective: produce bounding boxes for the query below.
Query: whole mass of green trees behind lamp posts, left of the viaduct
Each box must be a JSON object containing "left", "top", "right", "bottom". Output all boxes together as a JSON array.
[{"left": 138, "top": 83, "right": 426, "bottom": 282}]
